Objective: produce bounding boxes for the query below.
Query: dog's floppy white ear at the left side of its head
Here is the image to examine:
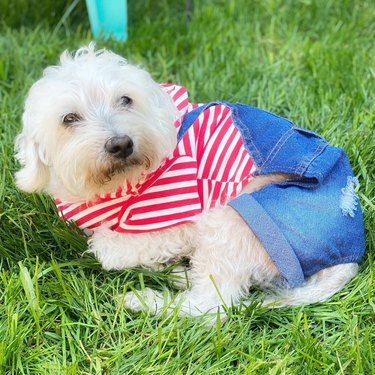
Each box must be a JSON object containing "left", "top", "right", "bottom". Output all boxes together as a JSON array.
[{"left": 15, "top": 130, "right": 49, "bottom": 193}]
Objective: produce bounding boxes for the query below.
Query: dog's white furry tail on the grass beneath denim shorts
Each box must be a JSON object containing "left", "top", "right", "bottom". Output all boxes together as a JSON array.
[{"left": 263, "top": 263, "right": 358, "bottom": 308}]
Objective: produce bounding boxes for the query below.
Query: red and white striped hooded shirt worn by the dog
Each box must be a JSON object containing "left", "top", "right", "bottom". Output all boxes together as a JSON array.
[{"left": 55, "top": 84, "right": 254, "bottom": 233}]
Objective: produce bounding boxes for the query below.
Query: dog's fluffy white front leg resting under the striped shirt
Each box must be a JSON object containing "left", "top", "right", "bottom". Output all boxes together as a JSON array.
[{"left": 88, "top": 225, "right": 192, "bottom": 270}]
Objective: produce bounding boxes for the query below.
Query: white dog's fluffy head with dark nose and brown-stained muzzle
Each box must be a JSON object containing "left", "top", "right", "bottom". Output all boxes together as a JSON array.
[{"left": 16, "top": 45, "right": 178, "bottom": 200}]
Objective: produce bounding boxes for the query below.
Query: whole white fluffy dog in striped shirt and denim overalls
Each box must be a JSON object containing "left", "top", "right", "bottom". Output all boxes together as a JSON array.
[{"left": 15, "top": 44, "right": 364, "bottom": 316}]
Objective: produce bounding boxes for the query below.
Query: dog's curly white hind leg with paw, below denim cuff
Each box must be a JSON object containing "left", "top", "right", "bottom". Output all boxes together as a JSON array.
[{"left": 125, "top": 207, "right": 279, "bottom": 315}]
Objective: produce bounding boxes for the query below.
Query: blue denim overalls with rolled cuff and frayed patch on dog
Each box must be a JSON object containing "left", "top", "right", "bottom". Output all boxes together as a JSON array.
[{"left": 178, "top": 102, "right": 365, "bottom": 287}]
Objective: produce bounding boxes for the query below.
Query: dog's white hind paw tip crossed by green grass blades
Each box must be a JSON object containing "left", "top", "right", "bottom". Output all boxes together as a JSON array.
[{"left": 124, "top": 288, "right": 165, "bottom": 314}]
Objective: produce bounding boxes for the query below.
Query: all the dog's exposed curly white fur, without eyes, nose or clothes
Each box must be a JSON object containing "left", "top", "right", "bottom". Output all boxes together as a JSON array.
[{"left": 16, "top": 45, "right": 357, "bottom": 315}]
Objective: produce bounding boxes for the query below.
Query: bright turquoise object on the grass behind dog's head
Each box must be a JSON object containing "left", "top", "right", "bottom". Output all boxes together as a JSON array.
[{"left": 86, "top": 0, "right": 128, "bottom": 41}]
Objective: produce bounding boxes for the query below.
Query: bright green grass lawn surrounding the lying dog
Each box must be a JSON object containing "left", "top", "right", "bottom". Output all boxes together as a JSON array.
[{"left": 0, "top": 0, "right": 375, "bottom": 375}]
